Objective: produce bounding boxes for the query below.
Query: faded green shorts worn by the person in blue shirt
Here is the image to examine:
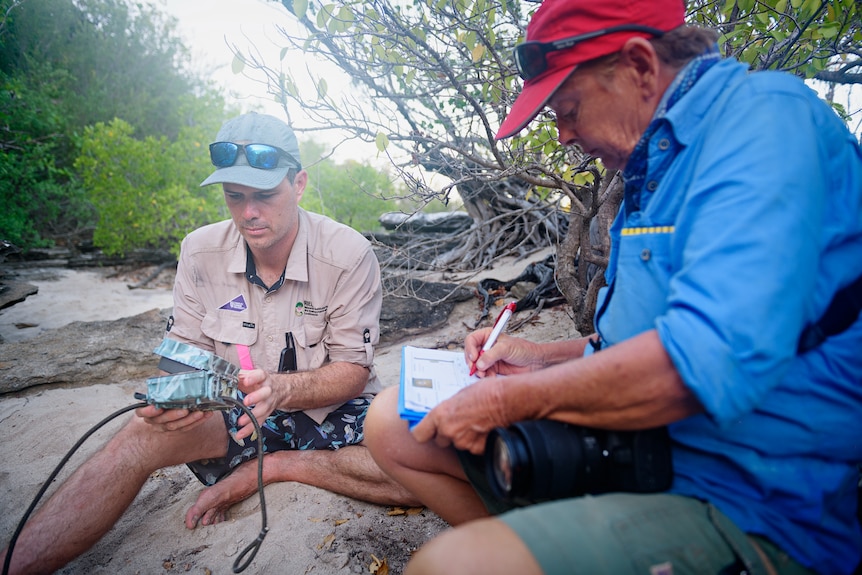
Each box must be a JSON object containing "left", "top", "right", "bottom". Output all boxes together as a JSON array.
[{"left": 459, "top": 452, "right": 814, "bottom": 575}]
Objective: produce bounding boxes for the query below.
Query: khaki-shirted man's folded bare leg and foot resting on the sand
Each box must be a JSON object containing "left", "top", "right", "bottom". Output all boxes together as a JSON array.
[{"left": 186, "top": 444, "right": 420, "bottom": 529}]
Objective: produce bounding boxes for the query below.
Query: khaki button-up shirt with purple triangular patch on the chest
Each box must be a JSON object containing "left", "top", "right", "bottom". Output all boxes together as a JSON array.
[{"left": 168, "top": 210, "right": 382, "bottom": 423}]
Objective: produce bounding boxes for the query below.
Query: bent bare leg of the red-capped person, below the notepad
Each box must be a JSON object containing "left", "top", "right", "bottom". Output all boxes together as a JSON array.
[{"left": 365, "top": 387, "right": 488, "bottom": 525}]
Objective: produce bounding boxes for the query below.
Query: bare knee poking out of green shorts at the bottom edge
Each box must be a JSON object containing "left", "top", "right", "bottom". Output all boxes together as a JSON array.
[{"left": 404, "top": 519, "right": 542, "bottom": 575}]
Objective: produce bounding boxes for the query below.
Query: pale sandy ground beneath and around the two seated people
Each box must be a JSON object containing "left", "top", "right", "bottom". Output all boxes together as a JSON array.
[{"left": 0, "top": 255, "right": 576, "bottom": 575}]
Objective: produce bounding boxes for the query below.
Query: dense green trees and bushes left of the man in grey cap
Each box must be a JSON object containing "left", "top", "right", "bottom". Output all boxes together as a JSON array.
[{"left": 0, "top": 0, "right": 230, "bottom": 253}]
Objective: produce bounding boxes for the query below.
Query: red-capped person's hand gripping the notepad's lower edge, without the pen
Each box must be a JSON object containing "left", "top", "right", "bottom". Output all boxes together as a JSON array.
[{"left": 413, "top": 378, "right": 512, "bottom": 455}]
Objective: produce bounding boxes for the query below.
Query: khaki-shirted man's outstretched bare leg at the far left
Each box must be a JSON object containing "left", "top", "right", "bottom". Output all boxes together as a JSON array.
[{"left": 0, "top": 417, "right": 227, "bottom": 574}]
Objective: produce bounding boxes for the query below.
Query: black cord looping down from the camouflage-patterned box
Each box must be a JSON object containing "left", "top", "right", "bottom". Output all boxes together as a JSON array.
[{"left": 3, "top": 394, "right": 269, "bottom": 575}]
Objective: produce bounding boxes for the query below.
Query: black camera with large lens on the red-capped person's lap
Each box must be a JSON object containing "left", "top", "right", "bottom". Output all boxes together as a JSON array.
[{"left": 485, "top": 419, "right": 673, "bottom": 503}]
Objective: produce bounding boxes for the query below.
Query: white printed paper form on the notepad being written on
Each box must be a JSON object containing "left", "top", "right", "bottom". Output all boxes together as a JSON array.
[{"left": 401, "top": 346, "right": 479, "bottom": 413}]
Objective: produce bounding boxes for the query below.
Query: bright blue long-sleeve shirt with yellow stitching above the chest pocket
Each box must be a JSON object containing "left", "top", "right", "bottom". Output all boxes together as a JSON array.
[{"left": 596, "top": 56, "right": 862, "bottom": 573}]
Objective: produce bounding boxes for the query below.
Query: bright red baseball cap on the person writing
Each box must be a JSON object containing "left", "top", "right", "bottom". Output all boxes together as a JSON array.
[{"left": 496, "top": 0, "right": 685, "bottom": 140}]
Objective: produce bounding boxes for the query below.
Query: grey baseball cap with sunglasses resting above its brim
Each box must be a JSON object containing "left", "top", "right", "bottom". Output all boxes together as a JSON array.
[{"left": 201, "top": 112, "right": 302, "bottom": 190}]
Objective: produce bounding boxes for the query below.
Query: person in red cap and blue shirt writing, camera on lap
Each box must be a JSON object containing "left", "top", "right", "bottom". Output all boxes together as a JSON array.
[{"left": 366, "top": 0, "right": 862, "bottom": 575}]
